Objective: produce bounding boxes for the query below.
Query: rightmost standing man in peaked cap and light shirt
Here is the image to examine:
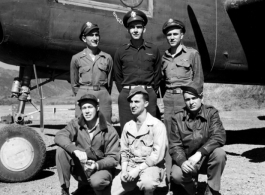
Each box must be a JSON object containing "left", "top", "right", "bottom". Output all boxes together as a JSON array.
[{"left": 161, "top": 18, "right": 204, "bottom": 185}]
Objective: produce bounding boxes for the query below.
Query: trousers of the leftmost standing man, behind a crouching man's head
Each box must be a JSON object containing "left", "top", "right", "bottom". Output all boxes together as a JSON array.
[{"left": 75, "top": 86, "right": 112, "bottom": 123}]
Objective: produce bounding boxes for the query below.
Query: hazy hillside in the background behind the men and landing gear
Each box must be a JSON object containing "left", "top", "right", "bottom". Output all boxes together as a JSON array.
[{"left": 0, "top": 67, "right": 265, "bottom": 110}]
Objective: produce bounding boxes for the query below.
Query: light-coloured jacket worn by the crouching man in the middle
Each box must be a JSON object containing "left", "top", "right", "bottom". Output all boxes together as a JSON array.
[{"left": 120, "top": 113, "right": 168, "bottom": 167}]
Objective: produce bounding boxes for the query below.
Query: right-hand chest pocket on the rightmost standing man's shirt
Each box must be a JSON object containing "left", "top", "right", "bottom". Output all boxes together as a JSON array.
[{"left": 176, "top": 59, "right": 192, "bottom": 79}]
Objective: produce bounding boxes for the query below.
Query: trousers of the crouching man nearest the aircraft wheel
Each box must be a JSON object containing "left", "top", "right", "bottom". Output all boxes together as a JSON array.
[{"left": 55, "top": 147, "right": 112, "bottom": 195}]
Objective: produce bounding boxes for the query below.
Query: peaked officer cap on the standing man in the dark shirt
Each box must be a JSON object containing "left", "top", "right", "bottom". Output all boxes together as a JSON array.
[{"left": 123, "top": 9, "right": 148, "bottom": 28}]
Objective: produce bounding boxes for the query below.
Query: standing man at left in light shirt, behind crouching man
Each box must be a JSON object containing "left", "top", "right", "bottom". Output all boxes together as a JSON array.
[{"left": 70, "top": 22, "right": 113, "bottom": 123}]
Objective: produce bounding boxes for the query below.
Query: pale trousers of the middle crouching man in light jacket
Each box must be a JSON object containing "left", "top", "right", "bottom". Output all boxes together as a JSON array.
[{"left": 111, "top": 166, "right": 164, "bottom": 195}]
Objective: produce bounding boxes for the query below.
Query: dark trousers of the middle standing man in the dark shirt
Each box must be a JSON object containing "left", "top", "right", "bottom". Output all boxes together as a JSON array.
[{"left": 118, "top": 88, "right": 157, "bottom": 131}]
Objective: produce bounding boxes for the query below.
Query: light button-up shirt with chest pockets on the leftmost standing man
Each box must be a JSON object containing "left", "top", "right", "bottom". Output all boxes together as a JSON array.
[{"left": 70, "top": 48, "right": 113, "bottom": 94}]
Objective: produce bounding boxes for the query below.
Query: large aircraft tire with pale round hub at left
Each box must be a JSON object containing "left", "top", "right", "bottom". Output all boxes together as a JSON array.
[{"left": 0, "top": 124, "right": 46, "bottom": 183}]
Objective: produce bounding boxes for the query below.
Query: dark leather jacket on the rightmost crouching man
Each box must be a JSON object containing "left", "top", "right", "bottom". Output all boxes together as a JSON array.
[{"left": 169, "top": 105, "right": 226, "bottom": 166}]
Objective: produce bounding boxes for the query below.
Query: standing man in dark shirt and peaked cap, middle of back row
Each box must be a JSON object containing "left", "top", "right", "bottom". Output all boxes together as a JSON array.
[{"left": 114, "top": 10, "right": 161, "bottom": 130}]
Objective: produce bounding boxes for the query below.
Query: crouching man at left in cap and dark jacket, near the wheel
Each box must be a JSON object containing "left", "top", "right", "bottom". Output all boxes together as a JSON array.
[{"left": 54, "top": 94, "right": 120, "bottom": 195}]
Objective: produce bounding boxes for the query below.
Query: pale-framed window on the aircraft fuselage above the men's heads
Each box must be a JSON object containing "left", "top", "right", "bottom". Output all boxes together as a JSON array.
[{"left": 58, "top": 0, "right": 153, "bottom": 18}]
